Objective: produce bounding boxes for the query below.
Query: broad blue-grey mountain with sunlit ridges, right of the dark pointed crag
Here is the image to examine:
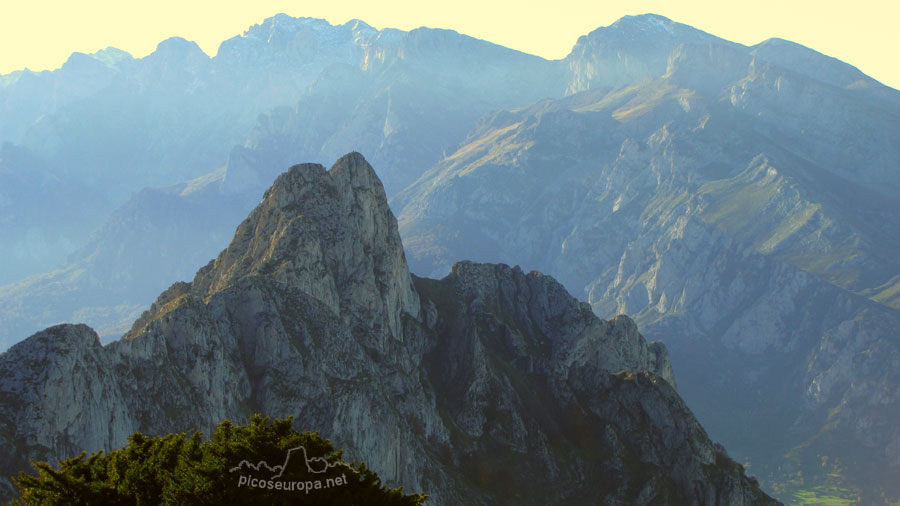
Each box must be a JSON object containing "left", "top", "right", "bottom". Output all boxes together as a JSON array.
[{"left": 392, "top": 23, "right": 900, "bottom": 504}]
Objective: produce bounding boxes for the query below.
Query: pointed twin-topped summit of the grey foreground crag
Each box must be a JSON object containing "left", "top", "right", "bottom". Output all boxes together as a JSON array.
[{"left": 132, "top": 153, "right": 419, "bottom": 336}]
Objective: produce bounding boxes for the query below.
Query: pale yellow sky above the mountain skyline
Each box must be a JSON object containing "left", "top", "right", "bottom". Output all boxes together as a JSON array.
[{"left": 0, "top": 0, "right": 900, "bottom": 88}]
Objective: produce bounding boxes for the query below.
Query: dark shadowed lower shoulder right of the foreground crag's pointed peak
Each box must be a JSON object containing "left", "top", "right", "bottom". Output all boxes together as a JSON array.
[{"left": 416, "top": 262, "right": 776, "bottom": 505}]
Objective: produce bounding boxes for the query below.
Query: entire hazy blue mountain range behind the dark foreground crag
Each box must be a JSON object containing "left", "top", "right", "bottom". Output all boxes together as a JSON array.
[{"left": 0, "top": 11, "right": 900, "bottom": 504}]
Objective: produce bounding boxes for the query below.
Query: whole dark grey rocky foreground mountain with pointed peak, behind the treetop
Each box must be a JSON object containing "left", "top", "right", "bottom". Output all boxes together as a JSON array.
[{"left": 0, "top": 153, "right": 776, "bottom": 505}]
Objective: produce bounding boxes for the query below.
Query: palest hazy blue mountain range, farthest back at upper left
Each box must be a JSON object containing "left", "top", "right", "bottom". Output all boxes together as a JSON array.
[{"left": 0, "top": 15, "right": 562, "bottom": 283}]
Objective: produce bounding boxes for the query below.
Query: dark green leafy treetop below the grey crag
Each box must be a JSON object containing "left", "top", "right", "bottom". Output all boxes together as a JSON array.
[{"left": 11, "top": 415, "right": 425, "bottom": 506}]
